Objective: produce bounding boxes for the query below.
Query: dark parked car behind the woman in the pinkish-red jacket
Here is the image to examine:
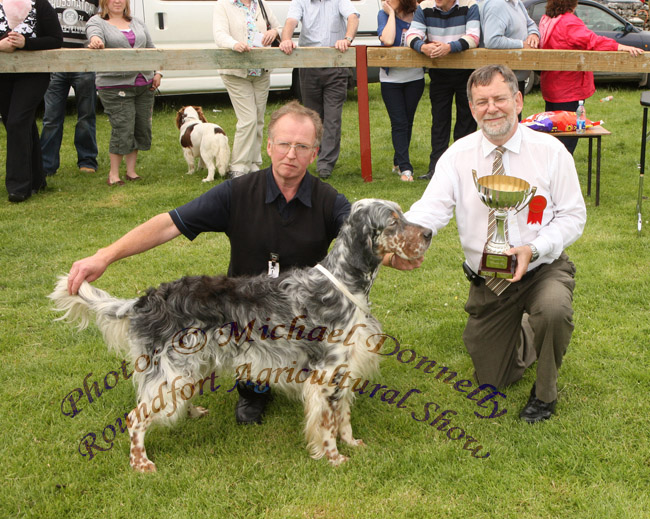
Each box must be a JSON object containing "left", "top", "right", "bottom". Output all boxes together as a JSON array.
[{"left": 523, "top": 0, "right": 650, "bottom": 93}]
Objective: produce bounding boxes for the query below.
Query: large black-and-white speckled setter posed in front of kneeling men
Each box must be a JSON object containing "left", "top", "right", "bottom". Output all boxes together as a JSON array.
[{"left": 49, "top": 199, "right": 432, "bottom": 472}]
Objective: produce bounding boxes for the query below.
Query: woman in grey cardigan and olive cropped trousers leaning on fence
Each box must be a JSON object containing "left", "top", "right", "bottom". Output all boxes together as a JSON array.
[{"left": 86, "top": 0, "right": 162, "bottom": 187}]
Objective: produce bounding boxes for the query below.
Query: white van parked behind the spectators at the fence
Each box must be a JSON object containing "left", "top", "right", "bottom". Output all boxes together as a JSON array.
[{"left": 131, "top": 0, "right": 381, "bottom": 94}]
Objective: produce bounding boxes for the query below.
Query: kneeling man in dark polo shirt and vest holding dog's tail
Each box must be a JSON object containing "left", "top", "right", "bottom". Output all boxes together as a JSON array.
[{"left": 68, "top": 101, "right": 350, "bottom": 424}]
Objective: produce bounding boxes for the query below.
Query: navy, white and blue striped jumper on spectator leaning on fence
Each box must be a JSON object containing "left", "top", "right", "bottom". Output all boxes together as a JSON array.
[{"left": 406, "top": 0, "right": 481, "bottom": 52}]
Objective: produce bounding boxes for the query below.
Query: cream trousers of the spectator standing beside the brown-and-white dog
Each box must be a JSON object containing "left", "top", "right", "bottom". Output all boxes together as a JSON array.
[{"left": 221, "top": 71, "right": 271, "bottom": 173}]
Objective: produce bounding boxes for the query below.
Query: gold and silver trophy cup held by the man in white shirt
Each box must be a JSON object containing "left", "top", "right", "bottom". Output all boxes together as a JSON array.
[{"left": 472, "top": 170, "right": 537, "bottom": 279}]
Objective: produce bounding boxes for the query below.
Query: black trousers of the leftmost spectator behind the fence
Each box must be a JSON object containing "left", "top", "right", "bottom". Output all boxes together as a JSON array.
[{"left": 0, "top": 73, "right": 50, "bottom": 196}]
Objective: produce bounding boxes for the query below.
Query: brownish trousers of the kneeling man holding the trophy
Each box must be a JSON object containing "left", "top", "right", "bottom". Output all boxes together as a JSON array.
[{"left": 463, "top": 253, "right": 575, "bottom": 402}]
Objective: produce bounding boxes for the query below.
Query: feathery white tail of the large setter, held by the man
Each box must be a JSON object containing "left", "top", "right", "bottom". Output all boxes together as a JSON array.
[{"left": 48, "top": 276, "right": 137, "bottom": 358}]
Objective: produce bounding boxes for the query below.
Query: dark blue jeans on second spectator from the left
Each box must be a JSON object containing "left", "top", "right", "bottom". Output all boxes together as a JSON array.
[{"left": 41, "top": 72, "right": 97, "bottom": 175}]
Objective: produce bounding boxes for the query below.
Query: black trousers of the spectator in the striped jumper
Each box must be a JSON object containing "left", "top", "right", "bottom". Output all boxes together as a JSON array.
[{"left": 429, "top": 69, "right": 476, "bottom": 171}]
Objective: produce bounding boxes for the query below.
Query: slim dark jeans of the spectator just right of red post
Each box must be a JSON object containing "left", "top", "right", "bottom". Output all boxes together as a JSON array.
[{"left": 381, "top": 79, "right": 424, "bottom": 171}]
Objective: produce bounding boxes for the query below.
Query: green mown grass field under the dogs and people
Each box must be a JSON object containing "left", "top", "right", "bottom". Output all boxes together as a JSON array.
[{"left": 0, "top": 81, "right": 650, "bottom": 519}]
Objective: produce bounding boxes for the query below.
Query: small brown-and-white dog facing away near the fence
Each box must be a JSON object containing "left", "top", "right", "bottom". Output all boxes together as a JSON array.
[{"left": 176, "top": 106, "right": 230, "bottom": 182}]
